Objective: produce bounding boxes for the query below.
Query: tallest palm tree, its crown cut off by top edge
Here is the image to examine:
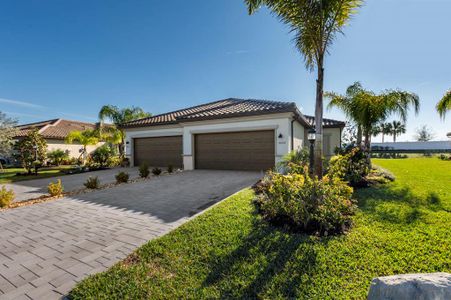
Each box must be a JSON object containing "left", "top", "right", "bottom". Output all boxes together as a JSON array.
[{"left": 245, "top": 0, "right": 363, "bottom": 178}]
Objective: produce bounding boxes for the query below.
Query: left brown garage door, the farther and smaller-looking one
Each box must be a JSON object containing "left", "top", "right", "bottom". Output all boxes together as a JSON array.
[{"left": 134, "top": 136, "right": 183, "bottom": 168}]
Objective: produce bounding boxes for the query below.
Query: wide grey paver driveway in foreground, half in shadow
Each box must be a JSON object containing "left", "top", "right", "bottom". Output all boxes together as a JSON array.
[{"left": 0, "top": 170, "right": 261, "bottom": 299}]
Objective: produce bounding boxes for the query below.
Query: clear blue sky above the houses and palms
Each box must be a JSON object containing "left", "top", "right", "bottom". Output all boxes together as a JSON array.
[{"left": 0, "top": 0, "right": 451, "bottom": 140}]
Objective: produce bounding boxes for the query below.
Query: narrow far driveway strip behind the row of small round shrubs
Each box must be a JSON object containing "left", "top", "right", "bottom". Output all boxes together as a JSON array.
[{"left": 6, "top": 168, "right": 139, "bottom": 201}]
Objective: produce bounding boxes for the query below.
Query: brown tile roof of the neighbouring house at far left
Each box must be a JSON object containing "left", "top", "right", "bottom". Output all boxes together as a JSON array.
[{"left": 16, "top": 119, "right": 97, "bottom": 140}]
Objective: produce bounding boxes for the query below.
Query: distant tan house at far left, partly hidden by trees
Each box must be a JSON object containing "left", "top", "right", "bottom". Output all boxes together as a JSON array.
[{"left": 15, "top": 119, "right": 103, "bottom": 158}]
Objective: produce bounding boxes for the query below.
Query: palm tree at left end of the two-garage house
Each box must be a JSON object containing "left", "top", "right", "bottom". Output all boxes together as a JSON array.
[{"left": 99, "top": 105, "right": 152, "bottom": 157}]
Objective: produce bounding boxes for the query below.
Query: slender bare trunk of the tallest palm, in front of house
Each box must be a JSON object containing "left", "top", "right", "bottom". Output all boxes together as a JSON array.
[{"left": 314, "top": 57, "right": 324, "bottom": 178}]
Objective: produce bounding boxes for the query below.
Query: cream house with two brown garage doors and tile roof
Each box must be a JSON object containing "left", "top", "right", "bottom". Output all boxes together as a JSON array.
[{"left": 122, "top": 99, "right": 345, "bottom": 170}]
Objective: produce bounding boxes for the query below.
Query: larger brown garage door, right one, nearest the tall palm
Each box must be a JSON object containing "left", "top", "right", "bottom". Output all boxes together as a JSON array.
[{"left": 195, "top": 130, "right": 275, "bottom": 170}]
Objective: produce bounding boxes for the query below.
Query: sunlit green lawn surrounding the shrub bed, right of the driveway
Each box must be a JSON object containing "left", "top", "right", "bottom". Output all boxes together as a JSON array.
[{"left": 70, "top": 158, "right": 451, "bottom": 299}]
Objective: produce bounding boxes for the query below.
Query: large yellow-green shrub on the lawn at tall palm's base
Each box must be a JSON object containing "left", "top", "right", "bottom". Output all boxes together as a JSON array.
[{"left": 256, "top": 172, "right": 356, "bottom": 235}]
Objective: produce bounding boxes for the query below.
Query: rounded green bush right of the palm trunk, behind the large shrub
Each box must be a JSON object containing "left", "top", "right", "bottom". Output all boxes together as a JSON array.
[{"left": 327, "top": 147, "right": 370, "bottom": 187}]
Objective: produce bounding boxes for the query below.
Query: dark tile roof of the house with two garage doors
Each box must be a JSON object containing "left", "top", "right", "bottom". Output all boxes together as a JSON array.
[{"left": 121, "top": 98, "right": 345, "bottom": 128}]
